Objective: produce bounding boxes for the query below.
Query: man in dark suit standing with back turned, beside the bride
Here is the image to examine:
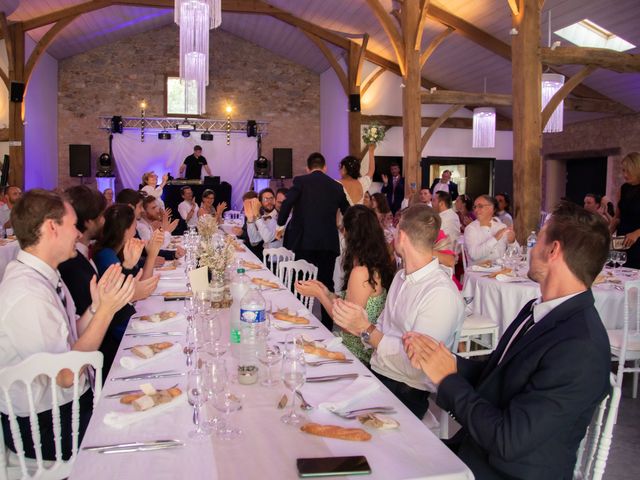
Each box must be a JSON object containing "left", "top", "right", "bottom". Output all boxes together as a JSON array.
[{"left": 278, "top": 152, "right": 349, "bottom": 330}]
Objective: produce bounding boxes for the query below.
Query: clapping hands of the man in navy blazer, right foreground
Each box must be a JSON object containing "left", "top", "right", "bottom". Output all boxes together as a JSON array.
[{"left": 402, "top": 332, "right": 458, "bottom": 385}]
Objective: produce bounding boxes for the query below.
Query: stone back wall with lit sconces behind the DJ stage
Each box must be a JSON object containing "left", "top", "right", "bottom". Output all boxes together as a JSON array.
[{"left": 58, "top": 25, "right": 320, "bottom": 187}]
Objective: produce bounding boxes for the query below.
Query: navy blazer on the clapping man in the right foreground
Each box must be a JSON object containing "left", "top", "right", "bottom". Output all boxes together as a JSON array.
[{"left": 436, "top": 290, "right": 611, "bottom": 480}]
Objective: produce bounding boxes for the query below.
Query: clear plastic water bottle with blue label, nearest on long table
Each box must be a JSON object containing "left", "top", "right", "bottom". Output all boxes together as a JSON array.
[{"left": 239, "top": 288, "right": 267, "bottom": 366}]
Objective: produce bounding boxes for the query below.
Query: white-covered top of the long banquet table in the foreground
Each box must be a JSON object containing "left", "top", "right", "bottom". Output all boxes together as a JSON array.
[{"left": 70, "top": 242, "right": 473, "bottom": 480}]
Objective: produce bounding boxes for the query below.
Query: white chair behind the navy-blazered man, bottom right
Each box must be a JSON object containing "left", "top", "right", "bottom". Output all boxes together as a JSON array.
[{"left": 573, "top": 374, "right": 621, "bottom": 480}]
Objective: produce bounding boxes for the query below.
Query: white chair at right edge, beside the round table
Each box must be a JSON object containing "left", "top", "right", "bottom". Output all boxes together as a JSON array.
[{"left": 607, "top": 280, "right": 640, "bottom": 398}]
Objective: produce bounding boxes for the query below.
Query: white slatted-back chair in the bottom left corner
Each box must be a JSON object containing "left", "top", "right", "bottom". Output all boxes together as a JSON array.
[{"left": 0, "top": 351, "right": 103, "bottom": 479}]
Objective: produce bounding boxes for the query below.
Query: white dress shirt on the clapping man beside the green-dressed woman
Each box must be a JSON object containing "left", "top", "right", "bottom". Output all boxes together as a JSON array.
[{"left": 371, "top": 258, "right": 464, "bottom": 391}]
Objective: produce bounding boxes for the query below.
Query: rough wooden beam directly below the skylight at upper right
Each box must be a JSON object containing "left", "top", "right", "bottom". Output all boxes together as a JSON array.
[{"left": 540, "top": 47, "right": 640, "bottom": 73}]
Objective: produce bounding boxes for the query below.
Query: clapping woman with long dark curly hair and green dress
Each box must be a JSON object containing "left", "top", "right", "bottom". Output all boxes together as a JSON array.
[{"left": 296, "top": 205, "right": 396, "bottom": 365}]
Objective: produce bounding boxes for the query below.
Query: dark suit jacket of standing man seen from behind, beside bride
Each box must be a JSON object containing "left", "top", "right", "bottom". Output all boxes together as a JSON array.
[{"left": 278, "top": 170, "right": 349, "bottom": 255}]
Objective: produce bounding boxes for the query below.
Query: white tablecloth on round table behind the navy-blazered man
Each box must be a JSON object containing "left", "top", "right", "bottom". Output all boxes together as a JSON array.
[{"left": 462, "top": 271, "right": 637, "bottom": 335}]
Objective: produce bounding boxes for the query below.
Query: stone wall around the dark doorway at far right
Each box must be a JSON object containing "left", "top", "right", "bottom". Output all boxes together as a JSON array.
[{"left": 542, "top": 114, "right": 640, "bottom": 207}]
